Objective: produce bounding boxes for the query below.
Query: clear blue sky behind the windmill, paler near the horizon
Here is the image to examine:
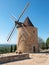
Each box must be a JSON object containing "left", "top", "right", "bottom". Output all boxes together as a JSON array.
[{"left": 0, "top": 0, "right": 49, "bottom": 44}]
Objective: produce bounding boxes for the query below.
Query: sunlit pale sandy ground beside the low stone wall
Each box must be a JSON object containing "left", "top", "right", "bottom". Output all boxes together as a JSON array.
[{"left": 1, "top": 53, "right": 49, "bottom": 65}]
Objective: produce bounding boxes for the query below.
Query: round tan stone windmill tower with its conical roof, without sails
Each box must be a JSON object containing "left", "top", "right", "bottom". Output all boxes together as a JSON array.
[{"left": 17, "top": 17, "right": 39, "bottom": 52}]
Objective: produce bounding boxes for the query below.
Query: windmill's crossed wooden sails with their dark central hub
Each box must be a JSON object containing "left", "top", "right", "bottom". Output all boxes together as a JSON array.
[{"left": 7, "top": 3, "right": 30, "bottom": 41}]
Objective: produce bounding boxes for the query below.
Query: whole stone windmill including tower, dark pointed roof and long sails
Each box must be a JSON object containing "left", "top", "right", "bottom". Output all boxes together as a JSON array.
[{"left": 7, "top": 3, "right": 39, "bottom": 53}]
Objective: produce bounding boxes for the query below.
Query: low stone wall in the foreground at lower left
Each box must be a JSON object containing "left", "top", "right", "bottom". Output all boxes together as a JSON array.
[{"left": 0, "top": 54, "right": 29, "bottom": 63}]
